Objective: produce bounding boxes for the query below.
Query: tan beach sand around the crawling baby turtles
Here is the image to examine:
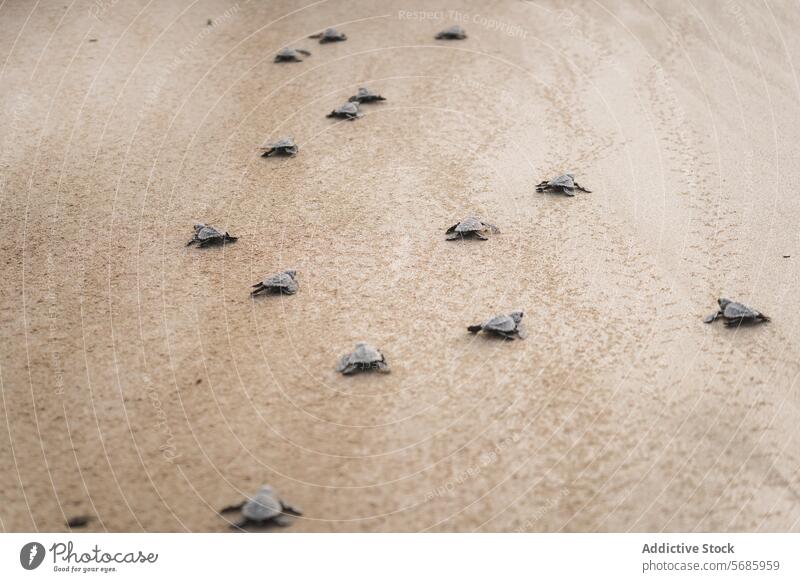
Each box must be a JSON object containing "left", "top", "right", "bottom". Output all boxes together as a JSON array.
[{"left": 0, "top": 0, "right": 800, "bottom": 532}]
